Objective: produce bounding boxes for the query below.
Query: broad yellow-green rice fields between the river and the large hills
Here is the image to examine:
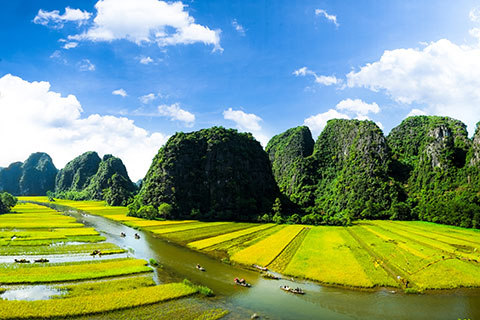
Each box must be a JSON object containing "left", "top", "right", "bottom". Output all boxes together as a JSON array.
[{"left": 19, "top": 197, "right": 480, "bottom": 293}]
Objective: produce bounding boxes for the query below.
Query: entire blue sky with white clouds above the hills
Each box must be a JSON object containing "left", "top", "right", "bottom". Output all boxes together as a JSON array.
[{"left": 0, "top": 0, "right": 480, "bottom": 180}]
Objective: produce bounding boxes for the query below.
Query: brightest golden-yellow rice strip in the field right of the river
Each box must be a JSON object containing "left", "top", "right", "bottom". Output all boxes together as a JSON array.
[{"left": 230, "top": 225, "right": 304, "bottom": 266}]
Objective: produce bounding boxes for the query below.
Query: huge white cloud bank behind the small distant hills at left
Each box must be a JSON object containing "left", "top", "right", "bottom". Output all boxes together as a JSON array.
[{"left": 0, "top": 74, "right": 167, "bottom": 180}]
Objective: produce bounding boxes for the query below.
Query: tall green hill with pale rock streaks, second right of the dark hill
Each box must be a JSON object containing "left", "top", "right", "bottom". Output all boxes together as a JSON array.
[{"left": 313, "top": 119, "right": 397, "bottom": 218}]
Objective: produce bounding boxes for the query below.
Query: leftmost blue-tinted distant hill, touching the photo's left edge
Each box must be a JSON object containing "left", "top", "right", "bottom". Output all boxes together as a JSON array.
[{"left": 0, "top": 152, "right": 57, "bottom": 196}]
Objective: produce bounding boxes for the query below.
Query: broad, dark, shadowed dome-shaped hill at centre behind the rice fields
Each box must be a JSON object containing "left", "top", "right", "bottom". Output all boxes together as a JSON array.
[{"left": 139, "top": 127, "right": 278, "bottom": 220}]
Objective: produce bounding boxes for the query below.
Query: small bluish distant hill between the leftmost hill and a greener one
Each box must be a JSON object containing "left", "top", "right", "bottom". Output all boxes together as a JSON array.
[{"left": 55, "top": 151, "right": 102, "bottom": 192}]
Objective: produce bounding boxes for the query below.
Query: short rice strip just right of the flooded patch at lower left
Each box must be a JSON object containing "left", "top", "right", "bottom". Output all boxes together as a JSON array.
[{"left": 55, "top": 276, "right": 155, "bottom": 298}]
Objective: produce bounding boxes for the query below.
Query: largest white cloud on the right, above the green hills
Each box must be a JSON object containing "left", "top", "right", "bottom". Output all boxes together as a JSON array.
[{"left": 347, "top": 39, "right": 480, "bottom": 133}]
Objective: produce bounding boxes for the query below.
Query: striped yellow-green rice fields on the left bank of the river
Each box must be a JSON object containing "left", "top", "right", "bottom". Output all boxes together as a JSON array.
[{"left": 0, "top": 202, "right": 226, "bottom": 319}]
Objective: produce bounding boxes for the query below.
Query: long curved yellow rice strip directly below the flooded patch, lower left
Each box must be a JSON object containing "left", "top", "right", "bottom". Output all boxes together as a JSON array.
[{"left": 0, "top": 283, "right": 196, "bottom": 319}]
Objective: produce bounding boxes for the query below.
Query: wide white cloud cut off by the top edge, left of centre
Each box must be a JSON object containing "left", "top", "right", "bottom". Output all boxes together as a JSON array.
[{"left": 69, "top": 0, "right": 223, "bottom": 51}]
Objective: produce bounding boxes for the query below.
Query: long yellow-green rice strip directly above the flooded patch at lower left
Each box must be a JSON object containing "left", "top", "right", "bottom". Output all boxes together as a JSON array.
[{"left": 0, "top": 258, "right": 152, "bottom": 284}]
